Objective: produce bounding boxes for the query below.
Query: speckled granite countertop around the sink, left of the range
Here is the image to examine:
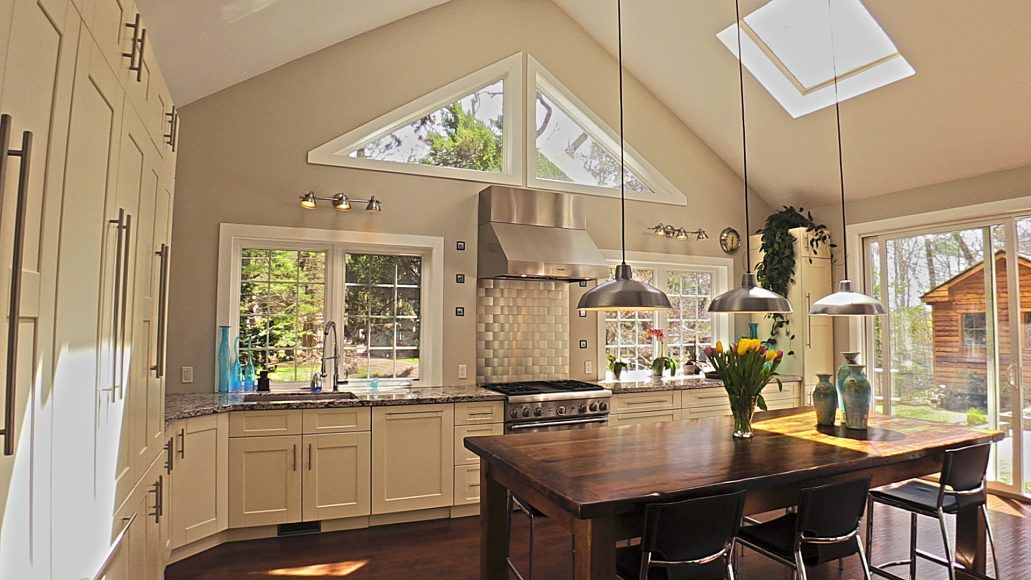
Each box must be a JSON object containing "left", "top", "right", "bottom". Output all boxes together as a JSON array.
[{"left": 165, "top": 386, "right": 505, "bottom": 424}]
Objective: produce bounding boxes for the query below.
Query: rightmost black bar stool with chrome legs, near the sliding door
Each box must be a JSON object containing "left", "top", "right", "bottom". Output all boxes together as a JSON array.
[{"left": 866, "top": 443, "right": 999, "bottom": 580}]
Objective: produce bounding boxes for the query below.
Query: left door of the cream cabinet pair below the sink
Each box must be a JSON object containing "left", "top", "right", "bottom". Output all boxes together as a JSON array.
[{"left": 229, "top": 435, "right": 302, "bottom": 527}]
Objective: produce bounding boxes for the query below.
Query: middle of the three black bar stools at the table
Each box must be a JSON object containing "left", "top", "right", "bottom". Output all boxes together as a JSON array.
[{"left": 737, "top": 477, "right": 870, "bottom": 580}]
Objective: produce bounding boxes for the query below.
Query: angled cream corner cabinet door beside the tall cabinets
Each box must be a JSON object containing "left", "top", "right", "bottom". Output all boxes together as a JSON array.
[{"left": 171, "top": 415, "right": 227, "bottom": 548}]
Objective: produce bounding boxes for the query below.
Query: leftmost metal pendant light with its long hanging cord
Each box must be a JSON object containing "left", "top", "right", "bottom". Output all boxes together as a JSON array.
[{"left": 576, "top": 0, "right": 672, "bottom": 311}]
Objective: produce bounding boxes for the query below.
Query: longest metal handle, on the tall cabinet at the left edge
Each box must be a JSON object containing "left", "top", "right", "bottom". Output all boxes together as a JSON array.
[{"left": 0, "top": 114, "right": 32, "bottom": 455}]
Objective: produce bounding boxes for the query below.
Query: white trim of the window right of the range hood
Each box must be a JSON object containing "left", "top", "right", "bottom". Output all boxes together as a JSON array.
[{"left": 596, "top": 249, "right": 734, "bottom": 378}]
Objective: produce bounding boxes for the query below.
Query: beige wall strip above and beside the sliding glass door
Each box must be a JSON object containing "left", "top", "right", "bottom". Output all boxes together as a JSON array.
[{"left": 812, "top": 166, "right": 1031, "bottom": 356}]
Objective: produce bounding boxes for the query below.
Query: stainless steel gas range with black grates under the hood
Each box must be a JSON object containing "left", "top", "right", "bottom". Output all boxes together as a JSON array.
[{"left": 484, "top": 380, "right": 612, "bottom": 432}]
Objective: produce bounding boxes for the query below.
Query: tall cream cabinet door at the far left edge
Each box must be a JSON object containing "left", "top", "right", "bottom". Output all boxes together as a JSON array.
[{"left": 0, "top": 0, "right": 75, "bottom": 578}]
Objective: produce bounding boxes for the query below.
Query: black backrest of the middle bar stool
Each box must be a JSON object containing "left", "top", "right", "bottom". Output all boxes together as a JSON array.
[{"left": 796, "top": 477, "right": 870, "bottom": 540}]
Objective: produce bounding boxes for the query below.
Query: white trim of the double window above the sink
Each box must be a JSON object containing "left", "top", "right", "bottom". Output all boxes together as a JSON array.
[{"left": 212, "top": 224, "right": 444, "bottom": 386}]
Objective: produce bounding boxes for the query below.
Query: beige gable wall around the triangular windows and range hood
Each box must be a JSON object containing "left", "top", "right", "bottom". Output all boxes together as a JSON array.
[{"left": 169, "top": 0, "right": 769, "bottom": 393}]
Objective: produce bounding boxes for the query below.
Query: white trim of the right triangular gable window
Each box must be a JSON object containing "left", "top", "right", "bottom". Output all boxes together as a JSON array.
[{"left": 524, "top": 55, "right": 688, "bottom": 205}]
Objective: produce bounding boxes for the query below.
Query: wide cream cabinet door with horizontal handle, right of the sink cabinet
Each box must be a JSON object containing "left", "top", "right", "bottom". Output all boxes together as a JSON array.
[{"left": 372, "top": 405, "right": 455, "bottom": 514}]
